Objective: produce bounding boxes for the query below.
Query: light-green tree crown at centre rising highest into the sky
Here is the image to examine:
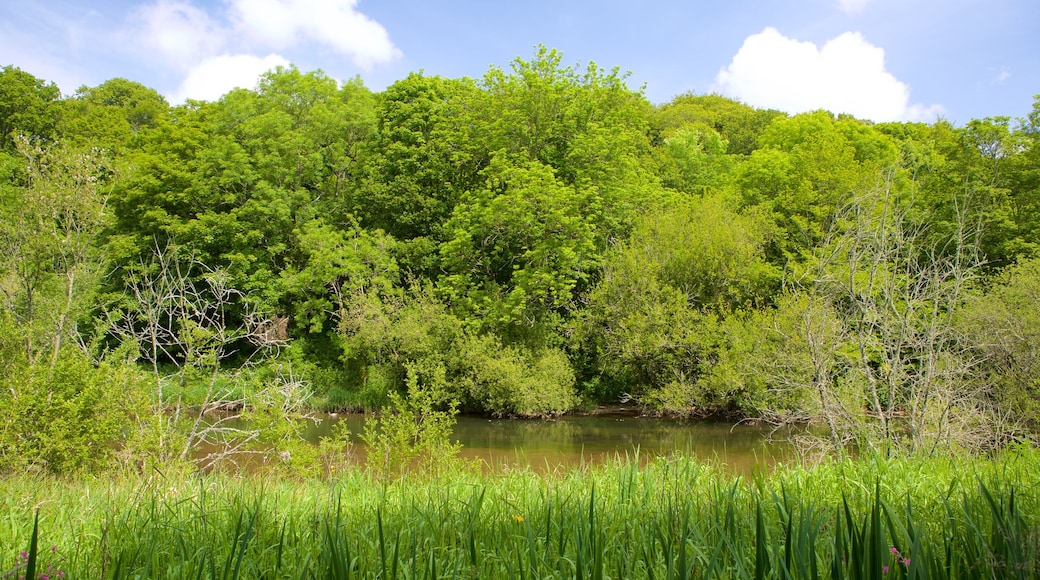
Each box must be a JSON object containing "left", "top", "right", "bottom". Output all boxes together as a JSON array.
[{"left": 474, "top": 47, "right": 660, "bottom": 253}]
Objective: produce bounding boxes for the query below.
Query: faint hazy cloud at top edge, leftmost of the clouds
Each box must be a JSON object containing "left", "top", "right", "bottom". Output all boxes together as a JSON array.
[{"left": 130, "top": 0, "right": 225, "bottom": 71}]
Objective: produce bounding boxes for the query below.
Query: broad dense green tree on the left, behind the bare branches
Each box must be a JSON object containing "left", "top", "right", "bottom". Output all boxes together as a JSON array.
[{"left": 107, "top": 69, "right": 367, "bottom": 328}]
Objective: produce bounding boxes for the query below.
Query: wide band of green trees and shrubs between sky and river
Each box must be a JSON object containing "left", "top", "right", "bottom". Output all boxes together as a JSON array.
[{"left": 0, "top": 48, "right": 1040, "bottom": 473}]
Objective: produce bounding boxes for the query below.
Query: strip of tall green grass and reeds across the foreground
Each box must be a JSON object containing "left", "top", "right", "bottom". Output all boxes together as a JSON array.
[{"left": 0, "top": 450, "right": 1040, "bottom": 579}]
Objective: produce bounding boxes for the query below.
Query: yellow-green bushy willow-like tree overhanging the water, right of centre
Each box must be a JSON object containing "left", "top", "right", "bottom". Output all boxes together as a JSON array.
[{"left": 579, "top": 196, "right": 778, "bottom": 414}]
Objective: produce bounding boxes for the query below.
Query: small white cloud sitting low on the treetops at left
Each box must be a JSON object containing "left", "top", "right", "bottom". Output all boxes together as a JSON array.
[{"left": 167, "top": 54, "right": 289, "bottom": 104}]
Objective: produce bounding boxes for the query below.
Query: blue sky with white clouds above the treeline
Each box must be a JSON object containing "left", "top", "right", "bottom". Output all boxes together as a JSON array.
[{"left": 0, "top": 0, "right": 1040, "bottom": 125}]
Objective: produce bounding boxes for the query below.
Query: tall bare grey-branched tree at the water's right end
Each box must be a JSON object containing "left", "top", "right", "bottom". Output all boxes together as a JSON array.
[{"left": 802, "top": 168, "right": 992, "bottom": 452}]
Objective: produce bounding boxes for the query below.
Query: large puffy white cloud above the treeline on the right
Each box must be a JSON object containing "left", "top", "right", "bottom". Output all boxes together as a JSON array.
[{"left": 711, "top": 27, "right": 942, "bottom": 122}]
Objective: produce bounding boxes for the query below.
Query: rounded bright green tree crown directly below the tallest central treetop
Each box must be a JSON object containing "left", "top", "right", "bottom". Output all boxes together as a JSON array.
[{"left": 440, "top": 158, "right": 596, "bottom": 336}]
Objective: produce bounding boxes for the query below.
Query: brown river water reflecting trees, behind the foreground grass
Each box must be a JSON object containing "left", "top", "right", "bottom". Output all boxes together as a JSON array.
[{"left": 307, "top": 415, "right": 792, "bottom": 474}]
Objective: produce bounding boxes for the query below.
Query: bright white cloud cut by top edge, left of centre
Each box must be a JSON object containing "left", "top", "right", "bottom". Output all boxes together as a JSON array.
[{"left": 231, "top": 0, "right": 400, "bottom": 69}]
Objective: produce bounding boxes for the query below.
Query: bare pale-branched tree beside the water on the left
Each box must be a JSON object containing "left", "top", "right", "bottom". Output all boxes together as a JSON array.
[{"left": 110, "top": 245, "right": 285, "bottom": 464}]
